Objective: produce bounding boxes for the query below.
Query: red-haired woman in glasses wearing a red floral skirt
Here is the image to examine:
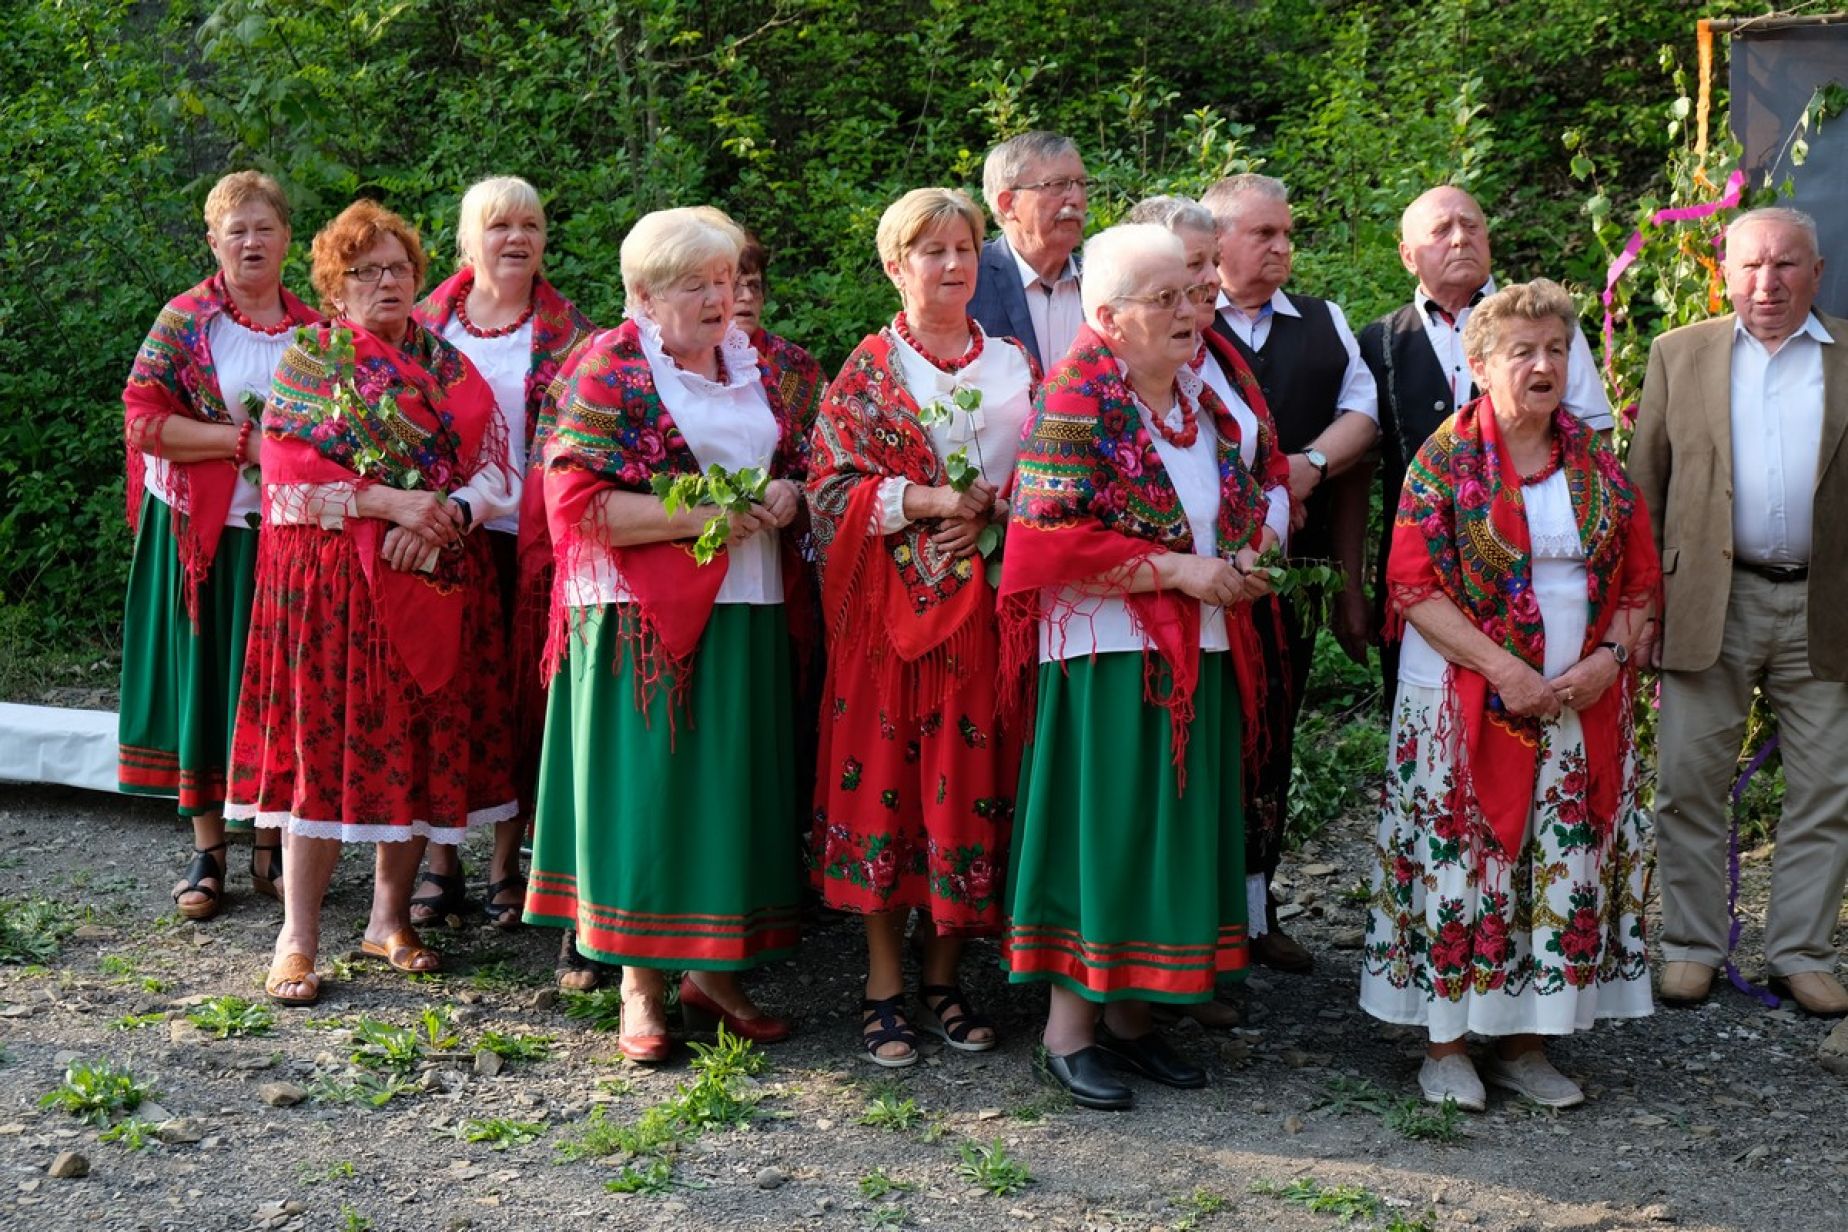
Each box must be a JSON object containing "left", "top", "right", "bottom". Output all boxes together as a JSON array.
[{"left": 225, "top": 201, "right": 519, "bottom": 1005}]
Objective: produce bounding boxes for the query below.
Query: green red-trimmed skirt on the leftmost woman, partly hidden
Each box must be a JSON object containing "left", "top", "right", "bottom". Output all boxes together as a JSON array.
[{"left": 116, "top": 493, "right": 257, "bottom": 829}]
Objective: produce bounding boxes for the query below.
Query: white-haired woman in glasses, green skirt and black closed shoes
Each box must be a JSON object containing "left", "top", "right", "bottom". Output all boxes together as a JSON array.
[{"left": 1002, "top": 223, "right": 1277, "bottom": 1108}]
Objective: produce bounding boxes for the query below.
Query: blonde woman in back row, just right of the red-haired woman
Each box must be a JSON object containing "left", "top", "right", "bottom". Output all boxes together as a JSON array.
[{"left": 410, "top": 175, "right": 591, "bottom": 938}]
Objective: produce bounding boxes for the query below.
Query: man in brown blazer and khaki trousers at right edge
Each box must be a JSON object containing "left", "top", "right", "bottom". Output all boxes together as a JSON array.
[{"left": 1628, "top": 209, "right": 1848, "bottom": 1018}]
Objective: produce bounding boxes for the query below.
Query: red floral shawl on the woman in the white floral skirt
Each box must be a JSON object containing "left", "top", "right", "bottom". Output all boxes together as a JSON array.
[{"left": 1386, "top": 395, "right": 1661, "bottom": 863}]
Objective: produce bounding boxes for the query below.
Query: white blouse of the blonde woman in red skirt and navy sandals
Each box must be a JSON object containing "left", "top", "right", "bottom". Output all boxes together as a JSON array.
[{"left": 880, "top": 325, "right": 1033, "bottom": 534}]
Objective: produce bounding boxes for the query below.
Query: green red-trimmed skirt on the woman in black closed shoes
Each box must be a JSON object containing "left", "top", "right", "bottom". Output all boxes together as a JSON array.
[{"left": 1002, "top": 652, "right": 1249, "bottom": 1003}]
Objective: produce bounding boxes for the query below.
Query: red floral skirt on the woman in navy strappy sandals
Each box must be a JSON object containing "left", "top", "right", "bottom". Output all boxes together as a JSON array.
[{"left": 808, "top": 621, "right": 1020, "bottom": 935}]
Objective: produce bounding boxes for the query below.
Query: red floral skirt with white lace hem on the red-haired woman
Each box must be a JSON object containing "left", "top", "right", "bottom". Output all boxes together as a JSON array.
[{"left": 225, "top": 526, "right": 516, "bottom": 842}]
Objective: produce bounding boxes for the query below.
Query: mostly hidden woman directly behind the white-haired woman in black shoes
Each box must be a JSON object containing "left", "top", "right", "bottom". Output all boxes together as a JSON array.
[{"left": 1124, "top": 196, "right": 1290, "bottom": 1027}]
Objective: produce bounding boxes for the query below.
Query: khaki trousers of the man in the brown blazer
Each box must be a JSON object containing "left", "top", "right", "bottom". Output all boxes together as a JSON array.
[{"left": 1656, "top": 569, "right": 1848, "bottom": 975}]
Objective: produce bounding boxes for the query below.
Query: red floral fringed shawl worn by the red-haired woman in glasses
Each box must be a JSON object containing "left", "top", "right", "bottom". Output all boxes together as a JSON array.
[{"left": 262, "top": 321, "right": 506, "bottom": 695}]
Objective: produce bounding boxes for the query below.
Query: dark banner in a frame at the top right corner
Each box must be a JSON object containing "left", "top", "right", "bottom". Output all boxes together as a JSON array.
[{"left": 1732, "top": 24, "right": 1848, "bottom": 316}]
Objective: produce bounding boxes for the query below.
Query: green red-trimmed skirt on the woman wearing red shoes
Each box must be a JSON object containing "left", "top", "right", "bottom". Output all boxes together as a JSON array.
[{"left": 527, "top": 604, "right": 800, "bottom": 972}]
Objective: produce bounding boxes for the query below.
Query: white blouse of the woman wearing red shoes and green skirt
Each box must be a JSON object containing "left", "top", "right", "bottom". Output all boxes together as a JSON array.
[{"left": 565, "top": 314, "right": 784, "bottom": 608}]
